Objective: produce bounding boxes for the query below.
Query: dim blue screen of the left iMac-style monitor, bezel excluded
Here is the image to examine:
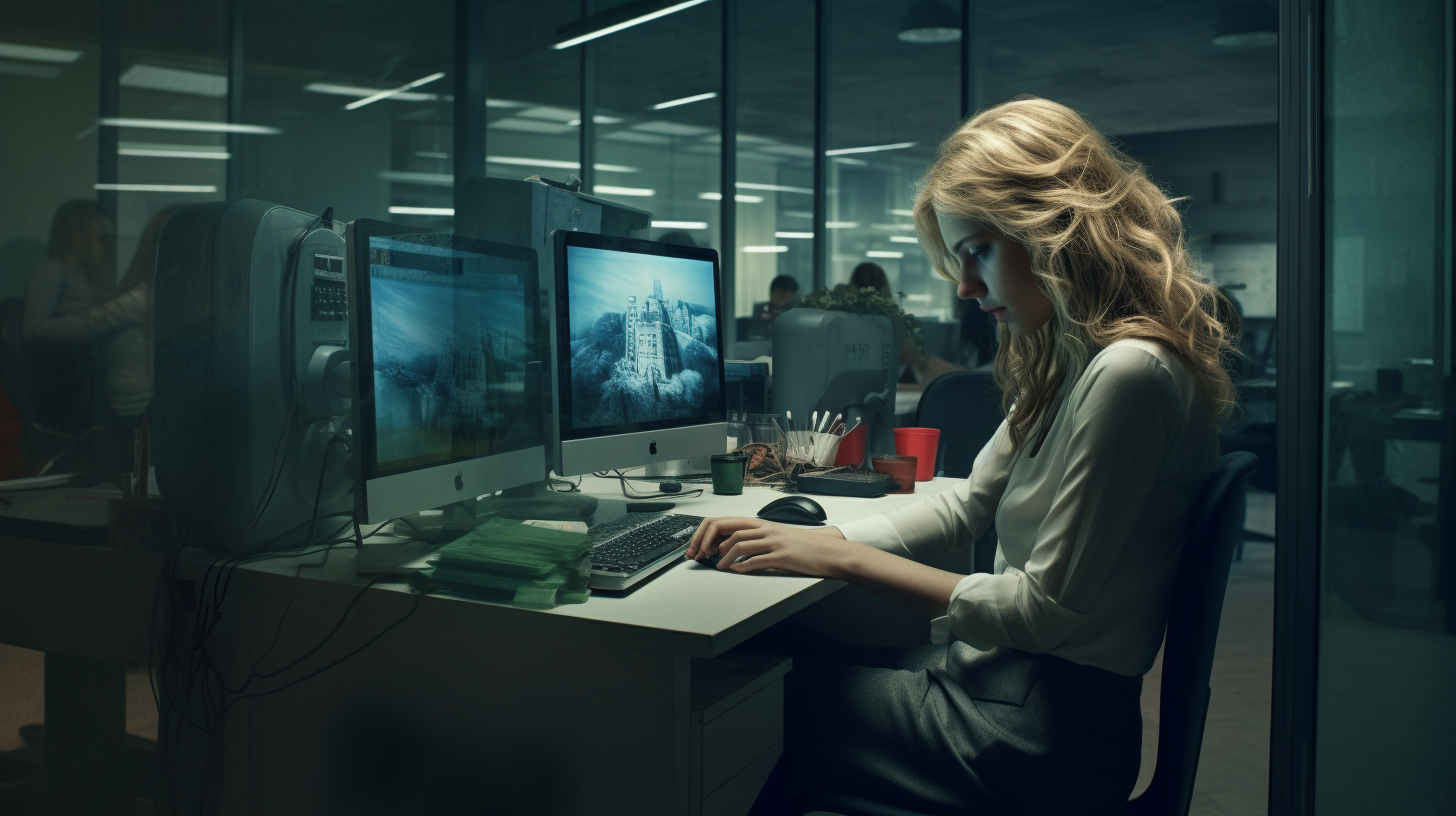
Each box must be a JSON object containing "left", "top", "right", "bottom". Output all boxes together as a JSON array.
[{"left": 360, "top": 233, "right": 543, "bottom": 476}]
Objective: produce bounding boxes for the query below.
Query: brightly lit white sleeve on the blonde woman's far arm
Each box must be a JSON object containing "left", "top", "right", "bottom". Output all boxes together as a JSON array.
[{"left": 839, "top": 423, "right": 1016, "bottom": 558}]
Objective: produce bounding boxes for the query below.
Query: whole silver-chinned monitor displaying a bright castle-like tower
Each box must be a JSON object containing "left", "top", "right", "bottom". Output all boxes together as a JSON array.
[{"left": 552, "top": 230, "right": 727, "bottom": 476}]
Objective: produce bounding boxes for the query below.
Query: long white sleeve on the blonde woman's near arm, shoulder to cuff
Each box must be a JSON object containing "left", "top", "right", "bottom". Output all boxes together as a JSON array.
[{"left": 949, "top": 347, "right": 1184, "bottom": 653}]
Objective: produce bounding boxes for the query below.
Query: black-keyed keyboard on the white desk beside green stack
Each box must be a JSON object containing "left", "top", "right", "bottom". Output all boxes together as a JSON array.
[{"left": 587, "top": 513, "right": 703, "bottom": 590}]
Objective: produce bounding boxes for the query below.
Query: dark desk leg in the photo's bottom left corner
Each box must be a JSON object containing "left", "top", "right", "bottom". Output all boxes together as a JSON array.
[{"left": 45, "top": 653, "right": 127, "bottom": 816}]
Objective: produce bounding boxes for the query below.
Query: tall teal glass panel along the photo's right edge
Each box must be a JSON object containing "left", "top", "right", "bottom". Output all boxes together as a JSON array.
[{"left": 1315, "top": 0, "right": 1456, "bottom": 816}]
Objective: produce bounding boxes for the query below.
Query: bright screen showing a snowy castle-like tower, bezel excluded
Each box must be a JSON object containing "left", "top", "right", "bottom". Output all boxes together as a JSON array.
[{"left": 558, "top": 236, "right": 724, "bottom": 439}]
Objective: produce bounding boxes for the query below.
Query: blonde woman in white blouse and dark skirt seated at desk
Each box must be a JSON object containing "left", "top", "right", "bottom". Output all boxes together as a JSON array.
[{"left": 687, "top": 99, "right": 1238, "bottom": 815}]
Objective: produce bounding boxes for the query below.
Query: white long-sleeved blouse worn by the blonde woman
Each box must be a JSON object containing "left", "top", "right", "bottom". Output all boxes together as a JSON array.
[{"left": 839, "top": 340, "right": 1219, "bottom": 676}]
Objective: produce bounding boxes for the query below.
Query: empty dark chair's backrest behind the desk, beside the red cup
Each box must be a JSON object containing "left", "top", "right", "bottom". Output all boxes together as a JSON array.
[{"left": 914, "top": 370, "right": 1005, "bottom": 478}]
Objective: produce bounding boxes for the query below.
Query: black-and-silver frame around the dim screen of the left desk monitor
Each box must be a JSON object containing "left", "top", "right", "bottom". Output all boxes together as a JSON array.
[{"left": 348, "top": 219, "right": 550, "bottom": 516}]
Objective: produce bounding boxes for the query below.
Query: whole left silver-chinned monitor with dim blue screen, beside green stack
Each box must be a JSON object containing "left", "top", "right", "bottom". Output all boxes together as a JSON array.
[{"left": 347, "top": 219, "right": 546, "bottom": 523}]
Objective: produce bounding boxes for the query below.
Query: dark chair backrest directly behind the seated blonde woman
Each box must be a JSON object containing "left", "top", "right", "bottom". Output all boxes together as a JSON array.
[{"left": 1125, "top": 452, "right": 1259, "bottom": 816}]
